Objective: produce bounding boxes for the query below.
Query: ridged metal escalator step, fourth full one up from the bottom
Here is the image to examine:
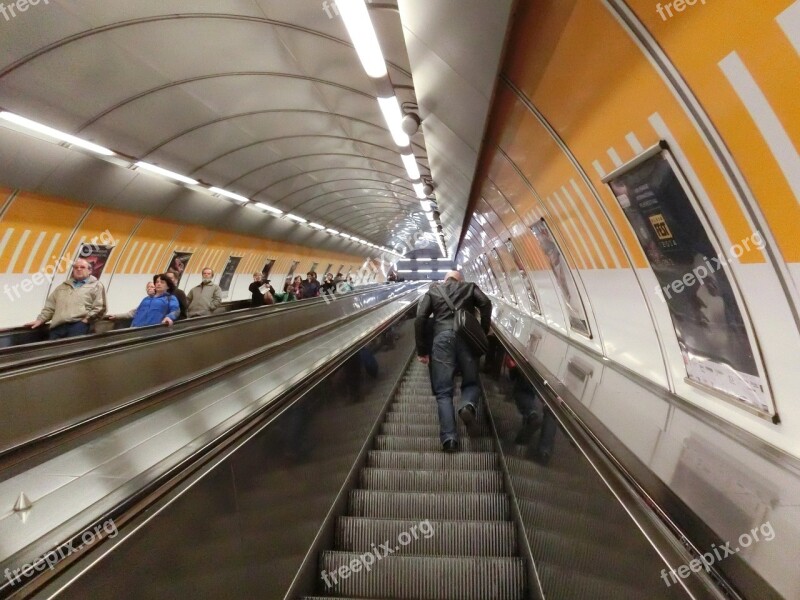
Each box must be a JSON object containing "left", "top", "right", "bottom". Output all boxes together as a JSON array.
[{"left": 361, "top": 469, "right": 503, "bottom": 494}]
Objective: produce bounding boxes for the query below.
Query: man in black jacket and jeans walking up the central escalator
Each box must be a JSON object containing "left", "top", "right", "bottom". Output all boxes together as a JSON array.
[{"left": 414, "top": 271, "right": 492, "bottom": 452}]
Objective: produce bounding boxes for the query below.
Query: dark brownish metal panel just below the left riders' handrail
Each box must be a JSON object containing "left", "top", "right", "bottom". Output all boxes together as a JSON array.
[{"left": 0, "top": 284, "right": 422, "bottom": 453}]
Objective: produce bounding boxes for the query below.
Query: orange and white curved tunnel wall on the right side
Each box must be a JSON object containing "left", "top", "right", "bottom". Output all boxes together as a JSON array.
[{"left": 459, "top": 0, "right": 800, "bottom": 456}]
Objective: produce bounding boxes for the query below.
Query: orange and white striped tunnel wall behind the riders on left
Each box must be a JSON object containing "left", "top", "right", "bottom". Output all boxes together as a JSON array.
[{"left": 0, "top": 188, "right": 364, "bottom": 327}]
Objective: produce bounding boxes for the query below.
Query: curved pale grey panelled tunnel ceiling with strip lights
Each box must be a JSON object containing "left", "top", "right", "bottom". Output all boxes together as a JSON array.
[{"left": 0, "top": 0, "right": 510, "bottom": 256}]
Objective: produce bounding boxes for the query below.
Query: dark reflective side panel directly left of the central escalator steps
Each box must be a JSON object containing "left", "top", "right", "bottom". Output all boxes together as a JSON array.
[{"left": 36, "top": 321, "right": 413, "bottom": 600}]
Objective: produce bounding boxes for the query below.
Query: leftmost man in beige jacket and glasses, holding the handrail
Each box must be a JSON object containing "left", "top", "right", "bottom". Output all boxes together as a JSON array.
[{"left": 25, "top": 258, "right": 106, "bottom": 340}]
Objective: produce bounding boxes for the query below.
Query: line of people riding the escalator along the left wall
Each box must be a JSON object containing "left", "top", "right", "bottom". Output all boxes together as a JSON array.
[{"left": 25, "top": 258, "right": 354, "bottom": 340}]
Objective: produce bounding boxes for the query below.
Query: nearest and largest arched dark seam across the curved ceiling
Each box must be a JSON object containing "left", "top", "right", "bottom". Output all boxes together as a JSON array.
[{"left": 0, "top": 13, "right": 412, "bottom": 79}]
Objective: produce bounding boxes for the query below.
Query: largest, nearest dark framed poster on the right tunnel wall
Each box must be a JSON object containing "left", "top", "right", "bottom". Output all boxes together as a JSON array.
[{"left": 604, "top": 146, "right": 774, "bottom": 415}]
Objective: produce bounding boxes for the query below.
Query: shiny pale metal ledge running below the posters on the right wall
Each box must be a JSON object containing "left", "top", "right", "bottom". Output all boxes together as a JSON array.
[{"left": 494, "top": 302, "right": 800, "bottom": 598}]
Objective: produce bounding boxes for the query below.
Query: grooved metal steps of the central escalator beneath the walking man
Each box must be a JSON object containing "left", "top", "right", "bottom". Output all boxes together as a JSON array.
[{"left": 306, "top": 362, "right": 526, "bottom": 600}]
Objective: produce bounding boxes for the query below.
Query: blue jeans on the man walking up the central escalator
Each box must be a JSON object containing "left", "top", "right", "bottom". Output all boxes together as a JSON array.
[{"left": 431, "top": 331, "right": 481, "bottom": 443}]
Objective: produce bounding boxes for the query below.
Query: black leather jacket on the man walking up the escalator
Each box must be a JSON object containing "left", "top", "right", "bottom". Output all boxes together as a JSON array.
[{"left": 414, "top": 279, "right": 492, "bottom": 356}]
